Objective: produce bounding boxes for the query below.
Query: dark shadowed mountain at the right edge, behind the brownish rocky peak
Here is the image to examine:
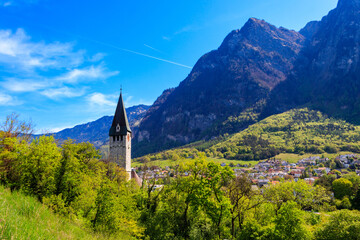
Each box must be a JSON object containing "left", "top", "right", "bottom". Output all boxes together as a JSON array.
[{"left": 264, "top": 0, "right": 360, "bottom": 124}]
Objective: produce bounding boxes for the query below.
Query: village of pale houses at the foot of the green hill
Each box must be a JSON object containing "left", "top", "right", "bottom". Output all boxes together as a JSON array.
[{"left": 134, "top": 154, "right": 360, "bottom": 188}]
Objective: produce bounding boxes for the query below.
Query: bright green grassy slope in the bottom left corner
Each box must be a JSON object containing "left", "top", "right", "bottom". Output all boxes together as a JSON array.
[{"left": 0, "top": 186, "right": 116, "bottom": 240}]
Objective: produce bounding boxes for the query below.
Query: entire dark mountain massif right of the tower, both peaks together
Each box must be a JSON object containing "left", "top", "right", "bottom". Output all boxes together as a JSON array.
[{"left": 134, "top": 0, "right": 360, "bottom": 156}]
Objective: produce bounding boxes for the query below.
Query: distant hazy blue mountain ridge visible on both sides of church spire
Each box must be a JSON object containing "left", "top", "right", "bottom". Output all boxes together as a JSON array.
[{"left": 52, "top": 105, "right": 149, "bottom": 147}]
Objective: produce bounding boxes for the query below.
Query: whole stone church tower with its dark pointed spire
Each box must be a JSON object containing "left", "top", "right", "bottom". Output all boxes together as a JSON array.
[{"left": 109, "top": 91, "right": 132, "bottom": 179}]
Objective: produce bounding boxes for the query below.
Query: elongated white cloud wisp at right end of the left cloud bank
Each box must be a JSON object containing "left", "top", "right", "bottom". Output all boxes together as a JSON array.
[{"left": 57, "top": 65, "right": 119, "bottom": 83}]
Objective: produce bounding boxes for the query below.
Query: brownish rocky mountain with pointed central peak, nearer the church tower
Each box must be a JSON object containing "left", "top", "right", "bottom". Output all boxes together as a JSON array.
[{"left": 133, "top": 18, "right": 306, "bottom": 156}]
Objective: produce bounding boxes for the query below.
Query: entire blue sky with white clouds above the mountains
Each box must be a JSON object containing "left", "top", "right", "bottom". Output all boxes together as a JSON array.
[{"left": 0, "top": 0, "right": 337, "bottom": 133}]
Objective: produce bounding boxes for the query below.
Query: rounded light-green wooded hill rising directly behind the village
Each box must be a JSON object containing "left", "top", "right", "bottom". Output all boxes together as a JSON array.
[{"left": 134, "top": 108, "right": 360, "bottom": 162}]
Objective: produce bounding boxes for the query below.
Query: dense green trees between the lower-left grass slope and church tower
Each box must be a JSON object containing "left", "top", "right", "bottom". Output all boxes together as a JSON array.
[{"left": 0, "top": 129, "right": 143, "bottom": 239}]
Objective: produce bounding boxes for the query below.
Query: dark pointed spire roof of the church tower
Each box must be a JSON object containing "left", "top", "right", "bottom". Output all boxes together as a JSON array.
[{"left": 109, "top": 92, "right": 131, "bottom": 136}]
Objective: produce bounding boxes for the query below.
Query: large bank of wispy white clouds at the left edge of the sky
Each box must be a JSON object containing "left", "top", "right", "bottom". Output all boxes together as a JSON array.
[{"left": 0, "top": 28, "right": 119, "bottom": 105}]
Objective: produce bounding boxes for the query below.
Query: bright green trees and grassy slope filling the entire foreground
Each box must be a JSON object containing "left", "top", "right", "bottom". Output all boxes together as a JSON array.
[{"left": 0, "top": 113, "right": 360, "bottom": 240}]
